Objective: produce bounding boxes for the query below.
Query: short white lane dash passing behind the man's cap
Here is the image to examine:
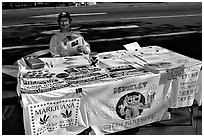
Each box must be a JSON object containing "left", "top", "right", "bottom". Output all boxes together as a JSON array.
[{"left": 29, "top": 12, "right": 107, "bottom": 18}]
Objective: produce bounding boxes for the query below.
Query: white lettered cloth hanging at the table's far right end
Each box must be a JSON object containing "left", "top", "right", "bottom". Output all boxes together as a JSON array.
[{"left": 170, "top": 65, "right": 201, "bottom": 108}]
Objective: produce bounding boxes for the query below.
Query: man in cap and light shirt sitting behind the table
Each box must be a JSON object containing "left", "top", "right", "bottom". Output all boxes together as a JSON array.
[{"left": 50, "top": 12, "right": 91, "bottom": 57}]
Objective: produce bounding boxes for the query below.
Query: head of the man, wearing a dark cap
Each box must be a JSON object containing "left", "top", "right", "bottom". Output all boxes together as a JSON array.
[{"left": 57, "top": 12, "right": 72, "bottom": 30}]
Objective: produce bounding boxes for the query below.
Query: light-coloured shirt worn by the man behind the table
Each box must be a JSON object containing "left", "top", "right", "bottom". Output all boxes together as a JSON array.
[{"left": 50, "top": 32, "right": 90, "bottom": 57}]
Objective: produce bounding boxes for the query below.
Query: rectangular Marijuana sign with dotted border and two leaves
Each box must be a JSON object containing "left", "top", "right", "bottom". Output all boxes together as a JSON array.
[{"left": 28, "top": 98, "right": 81, "bottom": 135}]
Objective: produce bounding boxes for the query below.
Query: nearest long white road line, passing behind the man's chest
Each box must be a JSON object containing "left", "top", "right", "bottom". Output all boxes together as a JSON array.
[{"left": 2, "top": 31, "right": 202, "bottom": 50}]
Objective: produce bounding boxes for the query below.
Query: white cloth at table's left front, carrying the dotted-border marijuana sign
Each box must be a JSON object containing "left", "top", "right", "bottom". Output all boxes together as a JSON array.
[{"left": 22, "top": 88, "right": 88, "bottom": 135}]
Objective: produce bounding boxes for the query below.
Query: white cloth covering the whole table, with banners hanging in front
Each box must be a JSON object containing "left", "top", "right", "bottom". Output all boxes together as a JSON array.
[{"left": 17, "top": 46, "right": 202, "bottom": 135}]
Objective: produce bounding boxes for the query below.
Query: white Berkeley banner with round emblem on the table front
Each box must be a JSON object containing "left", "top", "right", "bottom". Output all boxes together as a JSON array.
[{"left": 84, "top": 74, "right": 171, "bottom": 134}]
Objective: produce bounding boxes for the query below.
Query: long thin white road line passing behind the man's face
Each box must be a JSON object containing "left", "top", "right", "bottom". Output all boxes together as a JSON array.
[{"left": 2, "top": 14, "right": 202, "bottom": 28}]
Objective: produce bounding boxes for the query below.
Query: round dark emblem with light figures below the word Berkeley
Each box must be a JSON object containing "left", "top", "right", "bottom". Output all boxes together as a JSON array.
[{"left": 116, "top": 92, "right": 145, "bottom": 119}]
